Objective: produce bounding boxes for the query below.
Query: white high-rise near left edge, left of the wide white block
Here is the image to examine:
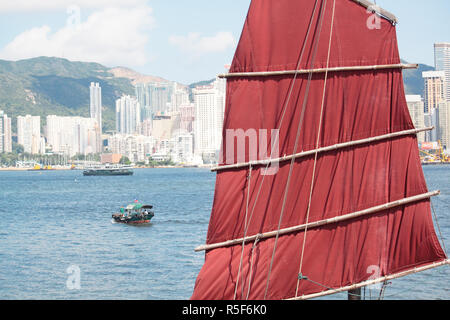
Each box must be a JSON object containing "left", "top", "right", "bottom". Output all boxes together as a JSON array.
[{"left": 17, "top": 115, "right": 45, "bottom": 154}]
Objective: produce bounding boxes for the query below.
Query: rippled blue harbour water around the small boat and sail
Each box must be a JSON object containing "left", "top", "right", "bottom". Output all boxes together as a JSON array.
[{"left": 0, "top": 166, "right": 450, "bottom": 300}]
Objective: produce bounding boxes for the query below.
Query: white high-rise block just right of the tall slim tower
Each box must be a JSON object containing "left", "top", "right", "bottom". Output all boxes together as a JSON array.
[{"left": 116, "top": 96, "right": 141, "bottom": 134}]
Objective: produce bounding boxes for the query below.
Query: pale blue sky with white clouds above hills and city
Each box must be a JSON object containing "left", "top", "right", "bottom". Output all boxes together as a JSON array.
[{"left": 0, "top": 0, "right": 450, "bottom": 84}]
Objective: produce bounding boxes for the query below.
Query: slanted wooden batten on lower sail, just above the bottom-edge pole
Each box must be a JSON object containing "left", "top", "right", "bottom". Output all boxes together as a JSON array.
[{"left": 195, "top": 190, "right": 440, "bottom": 252}]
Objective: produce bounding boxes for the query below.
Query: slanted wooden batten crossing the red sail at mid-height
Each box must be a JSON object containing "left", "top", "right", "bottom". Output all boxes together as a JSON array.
[{"left": 211, "top": 127, "right": 434, "bottom": 171}]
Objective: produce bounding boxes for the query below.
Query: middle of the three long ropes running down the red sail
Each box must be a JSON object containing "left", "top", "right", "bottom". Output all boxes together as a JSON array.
[{"left": 264, "top": 0, "right": 327, "bottom": 300}]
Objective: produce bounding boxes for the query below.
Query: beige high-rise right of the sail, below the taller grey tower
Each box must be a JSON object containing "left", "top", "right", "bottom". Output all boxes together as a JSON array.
[{"left": 422, "top": 71, "right": 446, "bottom": 113}]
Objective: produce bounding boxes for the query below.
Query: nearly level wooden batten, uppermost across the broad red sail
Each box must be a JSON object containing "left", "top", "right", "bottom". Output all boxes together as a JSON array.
[{"left": 218, "top": 63, "right": 419, "bottom": 78}]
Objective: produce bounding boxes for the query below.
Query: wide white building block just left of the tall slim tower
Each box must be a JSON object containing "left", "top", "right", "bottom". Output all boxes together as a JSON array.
[{"left": 46, "top": 115, "right": 102, "bottom": 157}]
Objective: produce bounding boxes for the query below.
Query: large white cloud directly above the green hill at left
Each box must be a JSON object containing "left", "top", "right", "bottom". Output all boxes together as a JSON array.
[{"left": 0, "top": 5, "right": 154, "bottom": 66}]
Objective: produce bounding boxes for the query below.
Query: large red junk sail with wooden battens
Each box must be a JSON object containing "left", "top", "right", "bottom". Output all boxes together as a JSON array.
[{"left": 192, "top": 0, "right": 446, "bottom": 300}]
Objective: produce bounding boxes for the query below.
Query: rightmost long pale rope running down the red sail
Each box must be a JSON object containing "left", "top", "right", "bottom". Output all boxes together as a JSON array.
[{"left": 295, "top": 0, "right": 336, "bottom": 297}]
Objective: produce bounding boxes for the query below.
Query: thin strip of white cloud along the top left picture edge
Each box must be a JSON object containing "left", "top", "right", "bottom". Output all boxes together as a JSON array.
[{"left": 0, "top": 0, "right": 148, "bottom": 13}]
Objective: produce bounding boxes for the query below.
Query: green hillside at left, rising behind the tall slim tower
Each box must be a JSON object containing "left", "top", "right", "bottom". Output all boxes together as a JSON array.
[{"left": 0, "top": 57, "right": 134, "bottom": 131}]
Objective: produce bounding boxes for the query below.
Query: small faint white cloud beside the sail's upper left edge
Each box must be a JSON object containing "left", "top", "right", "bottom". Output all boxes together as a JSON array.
[{"left": 169, "top": 32, "right": 236, "bottom": 56}]
